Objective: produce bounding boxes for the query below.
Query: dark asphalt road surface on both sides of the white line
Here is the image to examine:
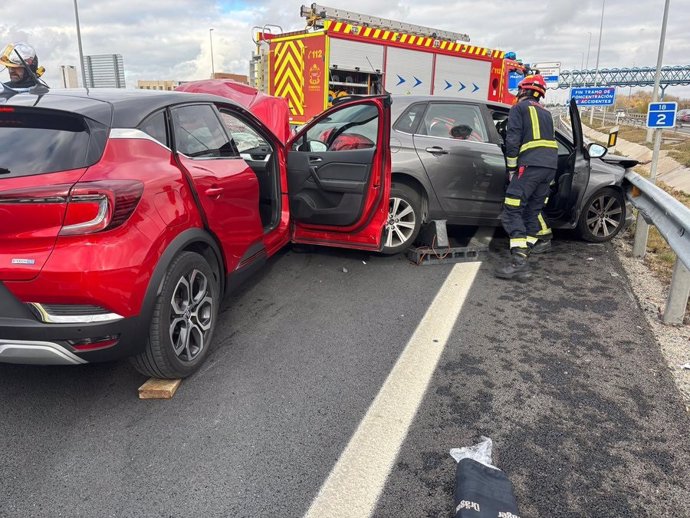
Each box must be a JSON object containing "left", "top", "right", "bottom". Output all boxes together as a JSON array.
[{"left": 0, "top": 232, "right": 690, "bottom": 518}]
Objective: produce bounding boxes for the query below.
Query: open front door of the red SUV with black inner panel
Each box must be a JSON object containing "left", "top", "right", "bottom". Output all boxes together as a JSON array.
[{"left": 287, "top": 96, "right": 391, "bottom": 254}]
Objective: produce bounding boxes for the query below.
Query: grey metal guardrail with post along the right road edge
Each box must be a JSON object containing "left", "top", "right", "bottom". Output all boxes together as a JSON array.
[{"left": 625, "top": 172, "right": 690, "bottom": 324}]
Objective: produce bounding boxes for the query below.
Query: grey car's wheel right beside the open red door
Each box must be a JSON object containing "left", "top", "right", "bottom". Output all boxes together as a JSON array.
[{"left": 381, "top": 183, "right": 422, "bottom": 255}]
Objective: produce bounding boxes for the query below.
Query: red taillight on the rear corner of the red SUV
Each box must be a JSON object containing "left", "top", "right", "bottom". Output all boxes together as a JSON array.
[{"left": 60, "top": 180, "right": 144, "bottom": 236}]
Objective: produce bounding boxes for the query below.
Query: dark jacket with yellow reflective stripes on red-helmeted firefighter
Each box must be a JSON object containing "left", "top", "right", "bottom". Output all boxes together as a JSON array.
[{"left": 506, "top": 97, "right": 558, "bottom": 169}]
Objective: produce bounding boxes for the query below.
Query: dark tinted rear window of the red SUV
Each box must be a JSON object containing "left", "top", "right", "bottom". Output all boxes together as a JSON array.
[{"left": 0, "top": 107, "right": 107, "bottom": 180}]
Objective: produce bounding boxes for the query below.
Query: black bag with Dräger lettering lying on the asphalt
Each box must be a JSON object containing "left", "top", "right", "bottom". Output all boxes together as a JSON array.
[{"left": 455, "top": 458, "right": 520, "bottom": 518}]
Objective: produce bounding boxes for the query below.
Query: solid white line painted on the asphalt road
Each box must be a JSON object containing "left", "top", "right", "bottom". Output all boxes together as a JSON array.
[{"left": 305, "top": 263, "right": 481, "bottom": 518}]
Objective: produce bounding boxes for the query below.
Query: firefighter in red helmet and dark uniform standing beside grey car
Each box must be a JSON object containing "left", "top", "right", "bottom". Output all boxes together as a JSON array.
[{"left": 496, "top": 74, "right": 558, "bottom": 281}]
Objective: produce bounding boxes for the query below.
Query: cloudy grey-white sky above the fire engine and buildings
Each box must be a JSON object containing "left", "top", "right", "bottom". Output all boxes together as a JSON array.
[{"left": 0, "top": 0, "right": 690, "bottom": 101}]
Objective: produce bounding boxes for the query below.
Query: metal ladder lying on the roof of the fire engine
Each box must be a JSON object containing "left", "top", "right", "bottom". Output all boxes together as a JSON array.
[{"left": 300, "top": 4, "right": 470, "bottom": 42}]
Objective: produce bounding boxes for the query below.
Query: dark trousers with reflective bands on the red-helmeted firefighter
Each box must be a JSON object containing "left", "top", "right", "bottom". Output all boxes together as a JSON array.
[{"left": 501, "top": 166, "right": 556, "bottom": 253}]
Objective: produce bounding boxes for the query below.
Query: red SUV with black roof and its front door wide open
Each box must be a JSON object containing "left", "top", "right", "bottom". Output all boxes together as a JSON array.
[{"left": 0, "top": 84, "right": 390, "bottom": 378}]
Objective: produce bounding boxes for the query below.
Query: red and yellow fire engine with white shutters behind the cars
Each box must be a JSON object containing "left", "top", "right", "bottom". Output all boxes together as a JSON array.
[{"left": 250, "top": 4, "right": 526, "bottom": 124}]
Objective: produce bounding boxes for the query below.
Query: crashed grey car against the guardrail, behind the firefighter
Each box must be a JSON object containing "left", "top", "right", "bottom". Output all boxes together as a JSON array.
[{"left": 383, "top": 96, "right": 637, "bottom": 254}]
